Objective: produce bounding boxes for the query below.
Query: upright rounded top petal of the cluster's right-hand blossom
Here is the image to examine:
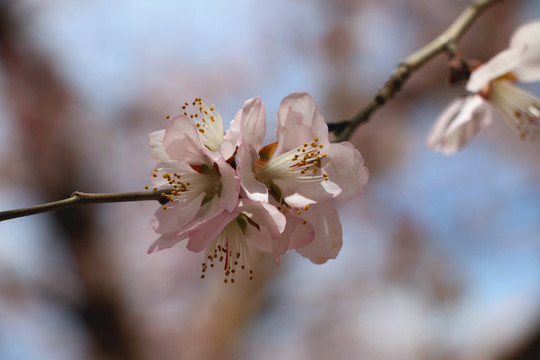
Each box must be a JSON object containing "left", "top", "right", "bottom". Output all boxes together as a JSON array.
[{"left": 277, "top": 92, "right": 328, "bottom": 142}]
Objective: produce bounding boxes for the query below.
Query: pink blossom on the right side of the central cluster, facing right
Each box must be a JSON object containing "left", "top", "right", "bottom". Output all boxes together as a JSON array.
[{"left": 238, "top": 92, "right": 368, "bottom": 207}]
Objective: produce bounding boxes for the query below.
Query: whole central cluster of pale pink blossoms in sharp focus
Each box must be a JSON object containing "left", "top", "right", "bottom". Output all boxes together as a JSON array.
[{"left": 148, "top": 92, "right": 368, "bottom": 282}]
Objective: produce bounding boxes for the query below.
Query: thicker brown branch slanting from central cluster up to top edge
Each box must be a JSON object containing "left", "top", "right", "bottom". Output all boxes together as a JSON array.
[{"left": 328, "top": 0, "right": 502, "bottom": 142}]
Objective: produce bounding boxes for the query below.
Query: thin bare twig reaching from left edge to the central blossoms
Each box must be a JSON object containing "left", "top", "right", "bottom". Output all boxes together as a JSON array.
[{"left": 0, "top": 189, "right": 174, "bottom": 221}]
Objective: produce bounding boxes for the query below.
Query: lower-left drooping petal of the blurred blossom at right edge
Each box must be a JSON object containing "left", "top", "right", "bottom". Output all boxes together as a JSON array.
[{"left": 426, "top": 95, "right": 492, "bottom": 155}]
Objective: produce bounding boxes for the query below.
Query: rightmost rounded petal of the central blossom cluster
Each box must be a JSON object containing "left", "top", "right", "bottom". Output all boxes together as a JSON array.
[{"left": 324, "top": 142, "right": 369, "bottom": 202}]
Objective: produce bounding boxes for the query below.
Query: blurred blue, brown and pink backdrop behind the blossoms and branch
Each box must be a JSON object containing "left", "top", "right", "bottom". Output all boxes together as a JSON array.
[{"left": 0, "top": 0, "right": 540, "bottom": 360}]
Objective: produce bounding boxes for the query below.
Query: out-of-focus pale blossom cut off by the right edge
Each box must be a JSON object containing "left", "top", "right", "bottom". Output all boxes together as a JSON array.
[{"left": 426, "top": 21, "right": 540, "bottom": 154}]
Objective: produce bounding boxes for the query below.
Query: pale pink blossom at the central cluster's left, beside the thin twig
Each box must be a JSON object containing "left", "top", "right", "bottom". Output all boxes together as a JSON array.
[{"left": 149, "top": 99, "right": 240, "bottom": 239}]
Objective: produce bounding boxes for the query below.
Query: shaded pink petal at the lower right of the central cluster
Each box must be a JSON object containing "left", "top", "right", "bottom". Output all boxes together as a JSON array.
[{"left": 296, "top": 202, "right": 343, "bottom": 264}]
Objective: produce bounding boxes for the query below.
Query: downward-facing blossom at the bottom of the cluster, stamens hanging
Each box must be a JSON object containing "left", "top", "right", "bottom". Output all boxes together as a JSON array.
[{"left": 148, "top": 199, "right": 285, "bottom": 282}]
